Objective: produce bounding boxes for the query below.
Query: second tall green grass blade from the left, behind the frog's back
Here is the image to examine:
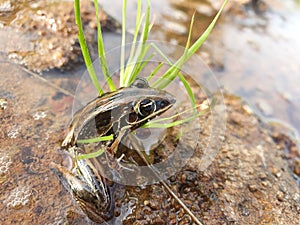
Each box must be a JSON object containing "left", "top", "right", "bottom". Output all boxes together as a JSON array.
[{"left": 94, "top": 0, "right": 116, "bottom": 91}]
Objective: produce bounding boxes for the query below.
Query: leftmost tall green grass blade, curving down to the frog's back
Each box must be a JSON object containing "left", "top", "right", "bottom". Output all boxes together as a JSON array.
[{"left": 74, "top": 0, "right": 104, "bottom": 95}]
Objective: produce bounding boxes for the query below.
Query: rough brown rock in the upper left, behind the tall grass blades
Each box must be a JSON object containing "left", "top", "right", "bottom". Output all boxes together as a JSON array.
[{"left": 0, "top": 0, "right": 118, "bottom": 71}]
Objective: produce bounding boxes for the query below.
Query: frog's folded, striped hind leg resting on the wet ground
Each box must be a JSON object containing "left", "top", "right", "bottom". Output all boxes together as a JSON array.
[{"left": 51, "top": 160, "right": 114, "bottom": 223}]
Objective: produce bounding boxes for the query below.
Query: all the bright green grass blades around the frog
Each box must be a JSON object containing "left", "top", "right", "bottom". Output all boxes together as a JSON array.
[{"left": 74, "top": 0, "right": 228, "bottom": 157}]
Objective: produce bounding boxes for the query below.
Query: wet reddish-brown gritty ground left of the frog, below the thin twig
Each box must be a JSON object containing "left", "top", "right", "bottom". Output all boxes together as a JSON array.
[{"left": 0, "top": 63, "right": 72, "bottom": 224}]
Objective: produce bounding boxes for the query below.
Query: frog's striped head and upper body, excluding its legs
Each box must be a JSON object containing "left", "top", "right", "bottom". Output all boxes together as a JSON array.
[{"left": 62, "top": 78, "right": 176, "bottom": 148}]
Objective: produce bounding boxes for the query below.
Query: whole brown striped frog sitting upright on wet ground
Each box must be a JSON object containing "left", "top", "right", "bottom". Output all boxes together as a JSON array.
[{"left": 53, "top": 79, "right": 175, "bottom": 222}]
